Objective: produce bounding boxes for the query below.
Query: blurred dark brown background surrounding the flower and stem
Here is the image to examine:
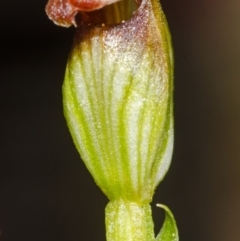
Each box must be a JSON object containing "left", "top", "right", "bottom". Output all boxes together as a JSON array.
[{"left": 0, "top": 0, "right": 240, "bottom": 241}]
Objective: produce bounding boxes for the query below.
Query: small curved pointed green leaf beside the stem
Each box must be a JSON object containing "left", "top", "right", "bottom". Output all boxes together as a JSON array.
[{"left": 156, "top": 204, "right": 179, "bottom": 241}]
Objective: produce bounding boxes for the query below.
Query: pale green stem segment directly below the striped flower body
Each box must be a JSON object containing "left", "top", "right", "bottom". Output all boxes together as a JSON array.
[{"left": 105, "top": 200, "right": 155, "bottom": 241}]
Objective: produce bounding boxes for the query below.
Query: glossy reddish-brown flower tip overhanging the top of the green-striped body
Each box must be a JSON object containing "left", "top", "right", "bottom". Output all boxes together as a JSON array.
[{"left": 46, "top": 0, "right": 119, "bottom": 27}]
